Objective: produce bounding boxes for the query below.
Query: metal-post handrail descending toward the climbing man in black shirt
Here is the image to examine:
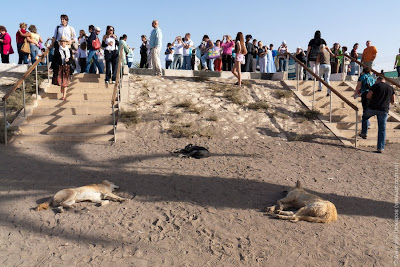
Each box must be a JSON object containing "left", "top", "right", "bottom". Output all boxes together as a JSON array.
[{"left": 287, "top": 53, "right": 358, "bottom": 147}]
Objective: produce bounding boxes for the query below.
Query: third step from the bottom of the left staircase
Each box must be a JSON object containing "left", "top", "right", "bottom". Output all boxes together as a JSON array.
[{"left": 27, "top": 115, "right": 113, "bottom": 125}]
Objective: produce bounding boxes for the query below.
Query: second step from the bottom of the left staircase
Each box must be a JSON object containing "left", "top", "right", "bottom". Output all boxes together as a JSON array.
[{"left": 20, "top": 124, "right": 113, "bottom": 134}]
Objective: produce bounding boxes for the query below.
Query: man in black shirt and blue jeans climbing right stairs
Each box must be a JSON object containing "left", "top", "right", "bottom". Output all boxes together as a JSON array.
[{"left": 360, "top": 77, "right": 394, "bottom": 153}]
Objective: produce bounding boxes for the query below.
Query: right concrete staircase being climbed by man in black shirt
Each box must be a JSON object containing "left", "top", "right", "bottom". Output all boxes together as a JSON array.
[{"left": 284, "top": 80, "right": 400, "bottom": 146}]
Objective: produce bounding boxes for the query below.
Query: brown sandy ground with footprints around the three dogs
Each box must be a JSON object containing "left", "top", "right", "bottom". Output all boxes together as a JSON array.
[{"left": 0, "top": 76, "right": 400, "bottom": 266}]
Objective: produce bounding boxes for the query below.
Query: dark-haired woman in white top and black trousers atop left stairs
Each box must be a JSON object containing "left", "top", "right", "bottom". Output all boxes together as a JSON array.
[{"left": 101, "top": 26, "right": 119, "bottom": 83}]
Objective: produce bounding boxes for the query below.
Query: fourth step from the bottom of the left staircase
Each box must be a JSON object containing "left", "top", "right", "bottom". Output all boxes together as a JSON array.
[{"left": 33, "top": 107, "right": 112, "bottom": 116}]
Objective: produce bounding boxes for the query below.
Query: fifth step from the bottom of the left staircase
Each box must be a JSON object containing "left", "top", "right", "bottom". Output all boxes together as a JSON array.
[{"left": 38, "top": 98, "right": 111, "bottom": 109}]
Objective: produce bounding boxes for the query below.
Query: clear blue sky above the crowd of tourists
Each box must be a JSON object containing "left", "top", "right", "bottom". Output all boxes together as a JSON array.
[{"left": 0, "top": 0, "right": 400, "bottom": 71}]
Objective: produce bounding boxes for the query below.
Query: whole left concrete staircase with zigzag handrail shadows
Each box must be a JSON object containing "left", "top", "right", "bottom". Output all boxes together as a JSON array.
[{"left": 15, "top": 74, "right": 114, "bottom": 142}]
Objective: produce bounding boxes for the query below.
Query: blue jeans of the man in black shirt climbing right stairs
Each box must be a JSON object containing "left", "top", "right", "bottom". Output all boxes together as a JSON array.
[{"left": 361, "top": 108, "right": 388, "bottom": 150}]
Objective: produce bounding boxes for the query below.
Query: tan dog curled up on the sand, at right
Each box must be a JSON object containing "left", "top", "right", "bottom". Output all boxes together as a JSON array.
[{"left": 267, "top": 181, "right": 337, "bottom": 223}]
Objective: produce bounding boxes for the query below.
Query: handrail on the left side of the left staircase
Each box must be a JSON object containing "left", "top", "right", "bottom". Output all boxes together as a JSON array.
[{"left": 2, "top": 49, "right": 50, "bottom": 145}]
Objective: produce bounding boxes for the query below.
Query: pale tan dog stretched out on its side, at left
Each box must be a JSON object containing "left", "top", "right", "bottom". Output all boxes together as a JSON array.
[{"left": 36, "top": 180, "right": 126, "bottom": 212}]
